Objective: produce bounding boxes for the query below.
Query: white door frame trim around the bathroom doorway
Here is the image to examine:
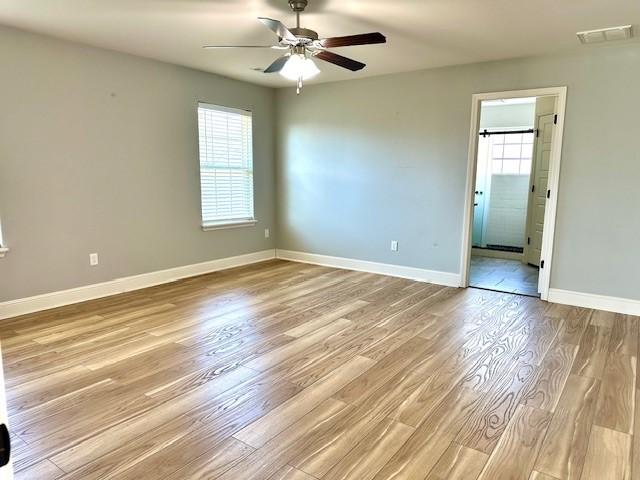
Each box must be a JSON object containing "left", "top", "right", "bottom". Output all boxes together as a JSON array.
[{"left": 460, "top": 86, "right": 567, "bottom": 300}]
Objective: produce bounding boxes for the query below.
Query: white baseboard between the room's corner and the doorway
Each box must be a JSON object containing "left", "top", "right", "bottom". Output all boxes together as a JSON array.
[{"left": 276, "top": 249, "right": 460, "bottom": 287}]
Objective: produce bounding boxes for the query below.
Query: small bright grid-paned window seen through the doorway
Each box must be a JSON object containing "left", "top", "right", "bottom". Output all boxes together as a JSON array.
[{"left": 491, "top": 133, "right": 533, "bottom": 175}]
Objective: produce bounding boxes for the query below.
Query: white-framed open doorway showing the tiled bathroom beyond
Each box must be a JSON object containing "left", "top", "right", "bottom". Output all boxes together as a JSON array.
[{"left": 461, "top": 87, "right": 566, "bottom": 300}]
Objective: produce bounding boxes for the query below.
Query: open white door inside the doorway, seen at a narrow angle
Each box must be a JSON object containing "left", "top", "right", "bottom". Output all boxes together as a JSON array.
[{"left": 527, "top": 113, "right": 555, "bottom": 267}]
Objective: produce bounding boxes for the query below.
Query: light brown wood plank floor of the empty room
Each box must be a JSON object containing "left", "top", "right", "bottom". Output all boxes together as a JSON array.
[{"left": 0, "top": 261, "right": 640, "bottom": 480}]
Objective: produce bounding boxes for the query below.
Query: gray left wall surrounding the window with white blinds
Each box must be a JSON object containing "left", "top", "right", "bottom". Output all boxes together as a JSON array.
[{"left": 0, "top": 27, "right": 275, "bottom": 301}]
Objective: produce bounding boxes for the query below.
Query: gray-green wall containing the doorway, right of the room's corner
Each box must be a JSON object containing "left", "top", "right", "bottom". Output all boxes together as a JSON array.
[{"left": 277, "top": 42, "right": 640, "bottom": 299}]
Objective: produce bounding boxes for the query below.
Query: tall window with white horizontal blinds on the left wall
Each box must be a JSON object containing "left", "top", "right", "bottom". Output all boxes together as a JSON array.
[{"left": 198, "top": 103, "right": 255, "bottom": 230}]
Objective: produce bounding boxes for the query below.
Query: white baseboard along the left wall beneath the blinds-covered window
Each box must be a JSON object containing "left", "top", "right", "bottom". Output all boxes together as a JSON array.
[{"left": 0, "top": 250, "right": 276, "bottom": 319}]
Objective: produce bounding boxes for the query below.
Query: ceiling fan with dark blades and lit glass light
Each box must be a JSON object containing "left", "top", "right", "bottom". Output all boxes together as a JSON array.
[{"left": 203, "top": 0, "right": 387, "bottom": 94}]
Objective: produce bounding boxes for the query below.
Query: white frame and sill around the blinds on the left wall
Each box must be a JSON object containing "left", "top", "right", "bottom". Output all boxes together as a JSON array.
[{"left": 196, "top": 101, "right": 258, "bottom": 231}]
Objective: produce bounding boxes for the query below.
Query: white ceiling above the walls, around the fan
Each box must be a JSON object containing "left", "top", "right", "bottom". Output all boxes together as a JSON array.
[{"left": 0, "top": 0, "right": 640, "bottom": 86}]
